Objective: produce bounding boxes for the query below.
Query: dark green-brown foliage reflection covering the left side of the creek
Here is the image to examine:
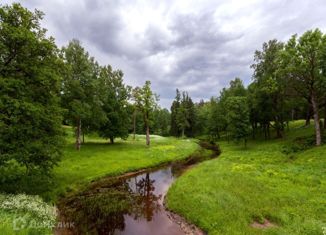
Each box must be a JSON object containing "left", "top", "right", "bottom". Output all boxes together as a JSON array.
[{"left": 62, "top": 183, "right": 133, "bottom": 235}]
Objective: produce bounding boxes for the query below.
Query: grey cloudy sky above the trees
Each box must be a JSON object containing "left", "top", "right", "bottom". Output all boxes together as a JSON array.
[{"left": 2, "top": 0, "right": 326, "bottom": 108}]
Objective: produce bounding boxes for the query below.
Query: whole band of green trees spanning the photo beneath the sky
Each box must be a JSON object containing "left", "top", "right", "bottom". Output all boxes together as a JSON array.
[{"left": 0, "top": 3, "right": 326, "bottom": 172}]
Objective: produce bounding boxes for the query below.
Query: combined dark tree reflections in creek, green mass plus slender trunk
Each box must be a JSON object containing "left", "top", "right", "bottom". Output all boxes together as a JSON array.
[{"left": 61, "top": 173, "right": 161, "bottom": 235}]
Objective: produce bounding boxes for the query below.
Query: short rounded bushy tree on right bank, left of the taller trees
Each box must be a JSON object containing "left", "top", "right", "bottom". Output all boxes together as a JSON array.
[{"left": 226, "top": 96, "right": 250, "bottom": 146}]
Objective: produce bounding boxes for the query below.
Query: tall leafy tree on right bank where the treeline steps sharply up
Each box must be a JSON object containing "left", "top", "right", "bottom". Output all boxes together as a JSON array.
[{"left": 249, "top": 39, "right": 289, "bottom": 138}]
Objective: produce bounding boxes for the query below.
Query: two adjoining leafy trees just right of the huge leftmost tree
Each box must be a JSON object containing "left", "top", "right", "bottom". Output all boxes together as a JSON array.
[{"left": 62, "top": 40, "right": 131, "bottom": 145}]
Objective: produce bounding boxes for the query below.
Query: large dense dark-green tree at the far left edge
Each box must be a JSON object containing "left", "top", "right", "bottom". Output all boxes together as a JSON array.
[{"left": 0, "top": 3, "right": 63, "bottom": 172}]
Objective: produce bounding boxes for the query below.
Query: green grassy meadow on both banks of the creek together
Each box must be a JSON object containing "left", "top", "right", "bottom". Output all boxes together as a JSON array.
[{"left": 0, "top": 121, "right": 326, "bottom": 235}]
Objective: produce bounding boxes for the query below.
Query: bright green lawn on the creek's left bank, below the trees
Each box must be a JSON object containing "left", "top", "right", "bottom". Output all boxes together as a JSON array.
[{"left": 51, "top": 129, "right": 198, "bottom": 200}]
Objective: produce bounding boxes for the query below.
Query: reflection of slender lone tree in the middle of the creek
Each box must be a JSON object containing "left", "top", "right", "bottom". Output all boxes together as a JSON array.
[{"left": 132, "top": 173, "right": 162, "bottom": 221}]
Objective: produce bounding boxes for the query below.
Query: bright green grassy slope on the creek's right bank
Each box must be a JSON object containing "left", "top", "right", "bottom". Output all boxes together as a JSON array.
[{"left": 167, "top": 123, "right": 326, "bottom": 235}]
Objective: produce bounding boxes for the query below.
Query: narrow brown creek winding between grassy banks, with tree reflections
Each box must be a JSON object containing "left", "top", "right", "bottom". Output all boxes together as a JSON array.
[{"left": 54, "top": 141, "right": 219, "bottom": 235}]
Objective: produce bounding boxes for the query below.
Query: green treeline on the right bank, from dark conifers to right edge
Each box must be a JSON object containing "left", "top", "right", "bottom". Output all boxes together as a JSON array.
[{"left": 171, "top": 33, "right": 326, "bottom": 146}]
